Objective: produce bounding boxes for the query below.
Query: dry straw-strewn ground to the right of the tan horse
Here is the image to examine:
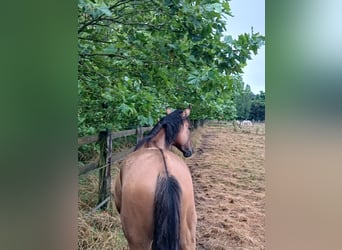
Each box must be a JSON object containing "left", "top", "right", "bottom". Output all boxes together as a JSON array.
[{"left": 187, "top": 125, "right": 265, "bottom": 250}]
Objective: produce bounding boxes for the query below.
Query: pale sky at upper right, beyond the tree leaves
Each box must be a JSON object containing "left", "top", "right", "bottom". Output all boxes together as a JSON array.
[{"left": 226, "top": 0, "right": 265, "bottom": 94}]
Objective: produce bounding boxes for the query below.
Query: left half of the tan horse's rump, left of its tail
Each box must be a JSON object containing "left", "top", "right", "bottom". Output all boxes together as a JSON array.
[{"left": 116, "top": 151, "right": 158, "bottom": 249}]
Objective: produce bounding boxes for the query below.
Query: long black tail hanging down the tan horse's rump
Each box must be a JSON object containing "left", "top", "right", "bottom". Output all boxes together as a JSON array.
[{"left": 152, "top": 173, "right": 182, "bottom": 250}]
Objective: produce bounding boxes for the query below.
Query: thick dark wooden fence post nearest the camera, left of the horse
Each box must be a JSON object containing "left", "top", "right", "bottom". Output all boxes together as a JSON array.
[{"left": 98, "top": 129, "right": 112, "bottom": 209}]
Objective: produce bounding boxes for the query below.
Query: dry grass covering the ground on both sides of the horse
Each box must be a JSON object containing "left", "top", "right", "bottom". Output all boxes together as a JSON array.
[{"left": 78, "top": 124, "right": 265, "bottom": 250}]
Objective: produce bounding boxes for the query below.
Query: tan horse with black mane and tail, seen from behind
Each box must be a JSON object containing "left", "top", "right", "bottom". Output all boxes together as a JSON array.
[{"left": 112, "top": 107, "right": 197, "bottom": 250}]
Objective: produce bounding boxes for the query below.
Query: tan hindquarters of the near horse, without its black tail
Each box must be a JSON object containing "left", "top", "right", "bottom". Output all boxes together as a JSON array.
[{"left": 115, "top": 149, "right": 196, "bottom": 249}]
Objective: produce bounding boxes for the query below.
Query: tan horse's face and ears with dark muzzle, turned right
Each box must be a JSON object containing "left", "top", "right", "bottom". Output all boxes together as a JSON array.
[{"left": 166, "top": 107, "right": 193, "bottom": 157}]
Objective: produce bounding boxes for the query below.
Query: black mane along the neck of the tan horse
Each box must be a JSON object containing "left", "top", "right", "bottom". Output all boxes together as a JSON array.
[{"left": 134, "top": 109, "right": 188, "bottom": 150}]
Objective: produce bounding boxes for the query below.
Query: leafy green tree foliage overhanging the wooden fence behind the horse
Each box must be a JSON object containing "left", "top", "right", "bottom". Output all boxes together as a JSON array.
[{"left": 78, "top": 0, "right": 264, "bottom": 136}]
